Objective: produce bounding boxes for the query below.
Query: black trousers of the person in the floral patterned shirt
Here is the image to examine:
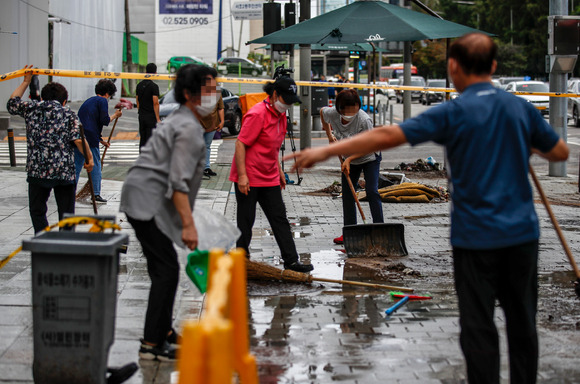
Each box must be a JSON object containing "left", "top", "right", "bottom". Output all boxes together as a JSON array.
[{"left": 28, "top": 183, "right": 76, "bottom": 233}]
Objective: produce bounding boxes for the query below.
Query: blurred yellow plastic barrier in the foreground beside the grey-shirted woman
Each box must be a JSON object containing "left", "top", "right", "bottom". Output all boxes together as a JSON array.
[{"left": 178, "top": 249, "right": 258, "bottom": 384}]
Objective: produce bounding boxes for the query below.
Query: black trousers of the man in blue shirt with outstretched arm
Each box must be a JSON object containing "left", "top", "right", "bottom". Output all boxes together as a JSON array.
[{"left": 453, "top": 241, "right": 538, "bottom": 384}]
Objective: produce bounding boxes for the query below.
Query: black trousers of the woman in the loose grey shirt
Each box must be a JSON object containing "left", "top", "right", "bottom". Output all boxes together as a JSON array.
[{"left": 127, "top": 216, "right": 179, "bottom": 345}]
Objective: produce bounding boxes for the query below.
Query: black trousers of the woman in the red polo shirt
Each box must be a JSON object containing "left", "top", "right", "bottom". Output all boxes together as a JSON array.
[{"left": 235, "top": 183, "right": 298, "bottom": 266}]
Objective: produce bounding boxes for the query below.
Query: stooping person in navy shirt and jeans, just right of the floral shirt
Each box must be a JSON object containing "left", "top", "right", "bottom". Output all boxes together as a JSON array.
[{"left": 75, "top": 79, "right": 123, "bottom": 203}]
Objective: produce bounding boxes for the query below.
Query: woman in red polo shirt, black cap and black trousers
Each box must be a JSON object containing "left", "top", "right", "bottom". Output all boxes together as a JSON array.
[{"left": 230, "top": 76, "right": 313, "bottom": 272}]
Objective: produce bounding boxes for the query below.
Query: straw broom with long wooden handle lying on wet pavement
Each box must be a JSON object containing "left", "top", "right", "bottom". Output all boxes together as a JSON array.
[{"left": 246, "top": 260, "right": 413, "bottom": 292}]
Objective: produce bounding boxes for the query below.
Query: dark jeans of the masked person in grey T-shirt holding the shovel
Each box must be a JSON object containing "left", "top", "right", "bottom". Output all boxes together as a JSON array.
[{"left": 342, "top": 155, "right": 385, "bottom": 225}]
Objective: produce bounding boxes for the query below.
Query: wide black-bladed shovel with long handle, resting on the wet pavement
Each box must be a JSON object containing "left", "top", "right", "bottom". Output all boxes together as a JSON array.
[{"left": 338, "top": 156, "right": 409, "bottom": 257}]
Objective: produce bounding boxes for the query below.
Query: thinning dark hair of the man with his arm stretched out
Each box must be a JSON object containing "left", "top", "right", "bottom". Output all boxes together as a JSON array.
[{"left": 449, "top": 32, "right": 497, "bottom": 75}]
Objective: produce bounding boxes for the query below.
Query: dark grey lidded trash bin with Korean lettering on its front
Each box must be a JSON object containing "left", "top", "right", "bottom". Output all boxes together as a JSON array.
[{"left": 22, "top": 231, "right": 129, "bottom": 384}]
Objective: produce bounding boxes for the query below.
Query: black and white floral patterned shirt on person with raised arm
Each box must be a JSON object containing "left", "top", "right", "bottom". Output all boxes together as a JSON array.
[{"left": 6, "top": 97, "right": 80, "bottom": 182}]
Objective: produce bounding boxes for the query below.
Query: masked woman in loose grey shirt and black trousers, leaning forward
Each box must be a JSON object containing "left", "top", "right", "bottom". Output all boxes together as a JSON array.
[{"left": 120, "top": 64, "right": 217, "bottom": 361}]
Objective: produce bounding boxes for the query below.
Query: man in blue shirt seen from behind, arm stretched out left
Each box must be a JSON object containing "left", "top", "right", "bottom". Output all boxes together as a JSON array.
[{"left": 287, "top": 33, "right": 568, "bottom": 383}]
